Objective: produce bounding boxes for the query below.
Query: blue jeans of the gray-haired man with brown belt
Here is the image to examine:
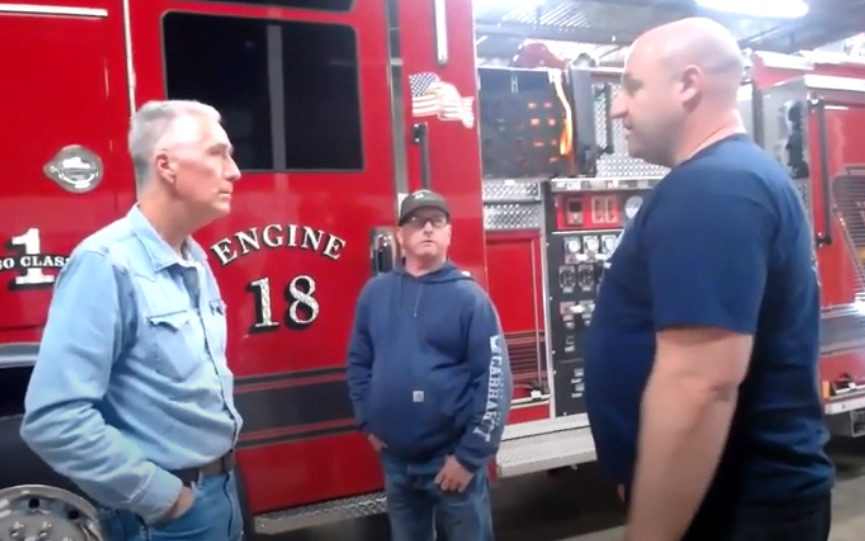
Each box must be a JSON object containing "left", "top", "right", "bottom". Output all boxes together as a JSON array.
[{"left": 100, "top": 473, "right": 243, "bottom": 541}]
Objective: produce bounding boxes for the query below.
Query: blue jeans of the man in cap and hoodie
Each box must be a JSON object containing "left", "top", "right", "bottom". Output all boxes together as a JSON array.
[{"left": 381, "top": 450, "right": 493, "bottom": 541}]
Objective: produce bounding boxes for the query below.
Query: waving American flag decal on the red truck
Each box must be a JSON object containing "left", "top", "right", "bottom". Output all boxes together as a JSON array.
[{"left": 408, "top": 71, "right": 475, "bottom": 128}]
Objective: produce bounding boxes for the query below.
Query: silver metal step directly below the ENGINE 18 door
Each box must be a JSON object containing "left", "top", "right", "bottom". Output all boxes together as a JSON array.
[{"left": 255, "top": 492, "right": 385, "bottom": 535}]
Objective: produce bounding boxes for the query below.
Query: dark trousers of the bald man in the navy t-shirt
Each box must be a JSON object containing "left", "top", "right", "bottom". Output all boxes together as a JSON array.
[{"left": 625, "top": 493, "right": 832, "bottom": 541}]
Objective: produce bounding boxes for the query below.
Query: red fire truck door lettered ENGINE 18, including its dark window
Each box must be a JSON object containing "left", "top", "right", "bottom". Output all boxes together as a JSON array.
[{"left": 131, "top": 0, "right": 396, "bottom": 516}]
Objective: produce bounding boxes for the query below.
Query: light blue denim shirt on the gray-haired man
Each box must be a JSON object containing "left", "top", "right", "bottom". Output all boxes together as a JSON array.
[{"left": 21, "top": 206, "right": 242, "bottom": 523}]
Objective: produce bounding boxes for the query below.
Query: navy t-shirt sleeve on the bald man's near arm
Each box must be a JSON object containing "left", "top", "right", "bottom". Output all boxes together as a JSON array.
[{"left": 642, "top": 166, "right": 773, "bottom": 334}]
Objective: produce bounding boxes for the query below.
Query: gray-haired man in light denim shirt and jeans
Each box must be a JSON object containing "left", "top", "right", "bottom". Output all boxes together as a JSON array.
[{"left": 21, "top": 101, "right": 243, "bottom": 541}]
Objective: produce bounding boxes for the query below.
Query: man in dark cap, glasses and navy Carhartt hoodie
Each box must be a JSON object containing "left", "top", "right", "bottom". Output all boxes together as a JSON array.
[{"left": 348, "top": 190, "right": 512, "bottom": 541}]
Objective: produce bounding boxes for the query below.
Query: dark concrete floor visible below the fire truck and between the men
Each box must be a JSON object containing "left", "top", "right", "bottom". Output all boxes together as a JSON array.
[{"left": 280, "top": 441, "right": 865, "bottom": 541}]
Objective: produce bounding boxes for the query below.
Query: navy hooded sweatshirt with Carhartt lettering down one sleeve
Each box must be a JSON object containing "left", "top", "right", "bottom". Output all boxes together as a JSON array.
[{"left": 347, "top": 263, "right": 513, "bottom": 472}]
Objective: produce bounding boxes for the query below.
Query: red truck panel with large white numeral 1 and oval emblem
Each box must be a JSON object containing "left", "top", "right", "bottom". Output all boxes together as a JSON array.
[{"left": 0, "top": 0, "right": 131, "bottom": 334}]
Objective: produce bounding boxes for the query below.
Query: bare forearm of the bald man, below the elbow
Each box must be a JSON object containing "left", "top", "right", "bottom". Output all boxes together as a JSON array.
[{"left": 628, "top": 375, "right": 736, "bottom": 541}]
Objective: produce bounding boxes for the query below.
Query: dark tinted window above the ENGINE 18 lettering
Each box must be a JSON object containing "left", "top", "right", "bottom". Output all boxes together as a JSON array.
[{"left": 163, "top": 12, "right": 363, "bottom": 171}]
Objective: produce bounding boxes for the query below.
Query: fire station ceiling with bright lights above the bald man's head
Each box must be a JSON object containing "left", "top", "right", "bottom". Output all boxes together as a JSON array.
[{"left": 474, "top": 0, "right": 865, "bottom": 65}]
